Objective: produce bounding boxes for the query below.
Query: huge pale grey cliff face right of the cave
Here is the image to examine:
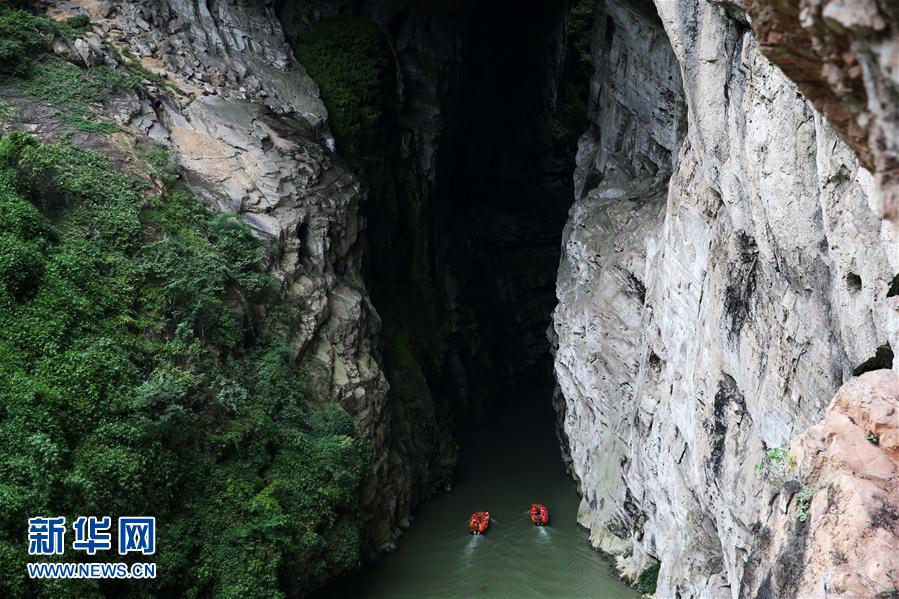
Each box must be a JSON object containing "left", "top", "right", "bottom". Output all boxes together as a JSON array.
[{"left": 554, "top": 0, "right": 899, "bottom": 597}]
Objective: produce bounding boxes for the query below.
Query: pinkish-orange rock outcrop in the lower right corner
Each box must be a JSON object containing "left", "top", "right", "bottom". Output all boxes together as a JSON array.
[{"left": 742, "top": 370, "right": 899, "bottom": 597}]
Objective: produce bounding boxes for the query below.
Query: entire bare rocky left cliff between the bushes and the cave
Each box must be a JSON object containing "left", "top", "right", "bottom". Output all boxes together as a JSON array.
[{"left": 60, "top": 1, "right": 417, "bottom": 552}]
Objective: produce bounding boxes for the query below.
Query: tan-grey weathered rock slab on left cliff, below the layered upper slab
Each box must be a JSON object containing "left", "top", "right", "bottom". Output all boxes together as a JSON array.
[{"left": 160, "top": 96, "right": 387, "bottom": 422}]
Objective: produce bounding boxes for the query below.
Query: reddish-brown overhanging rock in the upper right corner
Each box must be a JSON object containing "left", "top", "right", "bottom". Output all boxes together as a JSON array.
[{"left": 744, "top": 0, "right": 899, "bottom": 221}]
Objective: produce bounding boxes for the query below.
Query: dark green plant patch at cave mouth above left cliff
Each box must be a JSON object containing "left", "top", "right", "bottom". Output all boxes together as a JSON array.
[{"left": 294, "top": 17, "right": 393, "bottom": 175}]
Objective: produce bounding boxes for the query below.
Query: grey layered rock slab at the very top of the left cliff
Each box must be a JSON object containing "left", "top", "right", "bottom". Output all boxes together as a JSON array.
[{"left": 90, "top": 0, "right": 327, "bottom": 122}]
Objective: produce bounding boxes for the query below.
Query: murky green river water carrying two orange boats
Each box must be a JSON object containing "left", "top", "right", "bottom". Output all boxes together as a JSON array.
[{"left": 324, "top": 391, "right": 639, "bottom": 599}]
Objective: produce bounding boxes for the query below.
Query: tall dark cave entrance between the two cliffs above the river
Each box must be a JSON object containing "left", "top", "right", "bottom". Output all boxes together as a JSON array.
[{"left": 368, "top": 0, "right": 592, "bottom": 432}]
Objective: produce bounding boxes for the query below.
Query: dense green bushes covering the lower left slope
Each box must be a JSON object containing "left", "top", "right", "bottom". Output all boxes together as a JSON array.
[{"left": 0, "top": 133, "right": 370, "bottom": 597}]
